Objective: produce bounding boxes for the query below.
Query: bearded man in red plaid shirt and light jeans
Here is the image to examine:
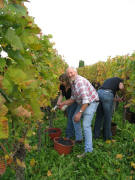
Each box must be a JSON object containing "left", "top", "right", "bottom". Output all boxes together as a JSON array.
[{"left": 61, "top": 67, "right": 99, "bottom": 157}]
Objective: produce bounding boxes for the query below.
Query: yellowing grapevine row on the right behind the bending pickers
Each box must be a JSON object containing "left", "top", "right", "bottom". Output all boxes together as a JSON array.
[{"left": 78, "top": 53, "right": 135, "bottom": 109}]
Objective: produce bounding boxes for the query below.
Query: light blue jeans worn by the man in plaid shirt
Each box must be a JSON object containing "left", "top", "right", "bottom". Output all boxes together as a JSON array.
[{"left": 73, "top": 102, "right": 98, "bottom": 152}]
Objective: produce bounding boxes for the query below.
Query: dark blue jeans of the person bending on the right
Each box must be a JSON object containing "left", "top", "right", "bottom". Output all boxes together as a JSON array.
[{"left": 94, "top": 89, "right": 114, "bottom": 141}]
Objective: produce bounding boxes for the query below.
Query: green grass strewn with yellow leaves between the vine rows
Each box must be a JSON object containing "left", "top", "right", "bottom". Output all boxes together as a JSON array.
[{"left": 2, "top": 103, "right": 135, "bottom": 180}]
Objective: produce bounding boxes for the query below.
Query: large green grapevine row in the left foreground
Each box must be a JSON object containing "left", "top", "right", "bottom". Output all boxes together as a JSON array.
[{"left": 0, "top": 0, "right": 67, "bottom": 176}]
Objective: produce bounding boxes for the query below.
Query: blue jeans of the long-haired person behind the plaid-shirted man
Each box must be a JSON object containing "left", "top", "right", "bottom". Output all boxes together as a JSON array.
[{"left": 66, "top": 102, "right": 77, "bottom": 138}]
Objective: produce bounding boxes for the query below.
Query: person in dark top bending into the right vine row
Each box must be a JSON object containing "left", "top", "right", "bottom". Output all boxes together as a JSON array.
[{"left": 94, "top": 77, "right": 124, "bottom": 141}]
